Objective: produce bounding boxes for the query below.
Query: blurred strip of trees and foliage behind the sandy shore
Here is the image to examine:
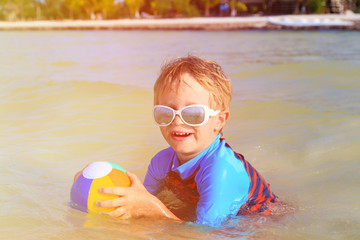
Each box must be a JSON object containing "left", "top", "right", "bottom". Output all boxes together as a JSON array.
[{"left": 0, "top": 0, "right": 360, "bottom": 21}]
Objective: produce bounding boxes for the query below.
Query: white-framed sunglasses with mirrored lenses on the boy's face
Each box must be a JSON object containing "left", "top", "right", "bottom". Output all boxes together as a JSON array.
[{"left": 153, "top": 104, "right": 220, "bottom": 127}]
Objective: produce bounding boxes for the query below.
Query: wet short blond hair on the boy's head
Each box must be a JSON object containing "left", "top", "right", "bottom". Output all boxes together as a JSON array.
[{"left": 154, "top": 55, "right": 232, "bottom": 110}]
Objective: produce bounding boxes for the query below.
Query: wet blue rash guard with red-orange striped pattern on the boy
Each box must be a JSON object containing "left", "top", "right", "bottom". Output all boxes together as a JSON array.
[{"left": 144, "top": 135, "right": 277, "bottom": 226}]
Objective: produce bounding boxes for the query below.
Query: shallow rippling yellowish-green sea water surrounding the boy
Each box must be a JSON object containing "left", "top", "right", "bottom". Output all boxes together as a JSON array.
[{"left": 0, "top": 31, "right": 360, "bottom": 240}]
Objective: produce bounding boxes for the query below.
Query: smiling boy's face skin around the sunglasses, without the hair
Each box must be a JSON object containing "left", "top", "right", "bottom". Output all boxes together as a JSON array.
[{"left": 158, "top": 74, "right": 226, "bottom": 164}]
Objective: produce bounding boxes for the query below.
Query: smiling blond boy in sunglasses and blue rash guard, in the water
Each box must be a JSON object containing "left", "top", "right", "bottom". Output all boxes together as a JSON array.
[{"left": 97, "top": 56, "right": 277, "bottom": 225}]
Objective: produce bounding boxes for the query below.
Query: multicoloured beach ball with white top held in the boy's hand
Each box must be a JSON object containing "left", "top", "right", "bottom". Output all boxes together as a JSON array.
[{"left": 70, "top": 161, "right": 130, "bottom": 213}]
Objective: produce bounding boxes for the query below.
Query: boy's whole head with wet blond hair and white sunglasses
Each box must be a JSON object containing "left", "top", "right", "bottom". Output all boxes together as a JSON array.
[{"left": 153, "top": 56, "right": 231, "bottom": 163}]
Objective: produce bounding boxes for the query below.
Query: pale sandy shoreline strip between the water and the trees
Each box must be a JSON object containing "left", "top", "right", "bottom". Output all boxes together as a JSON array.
[{"left": 0, "top": 14, "right": 360, "bottom": 31}]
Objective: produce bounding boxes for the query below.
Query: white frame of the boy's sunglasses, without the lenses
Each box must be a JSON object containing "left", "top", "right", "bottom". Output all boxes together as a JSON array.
[{"left": 153, "top": 104, "right": 221, "bottom": 127}]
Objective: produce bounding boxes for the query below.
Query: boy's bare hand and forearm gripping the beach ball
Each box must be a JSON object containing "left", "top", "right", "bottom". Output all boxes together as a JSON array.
[{"left": 96, "top": 172, "right": 178, "bottom": 220}]
